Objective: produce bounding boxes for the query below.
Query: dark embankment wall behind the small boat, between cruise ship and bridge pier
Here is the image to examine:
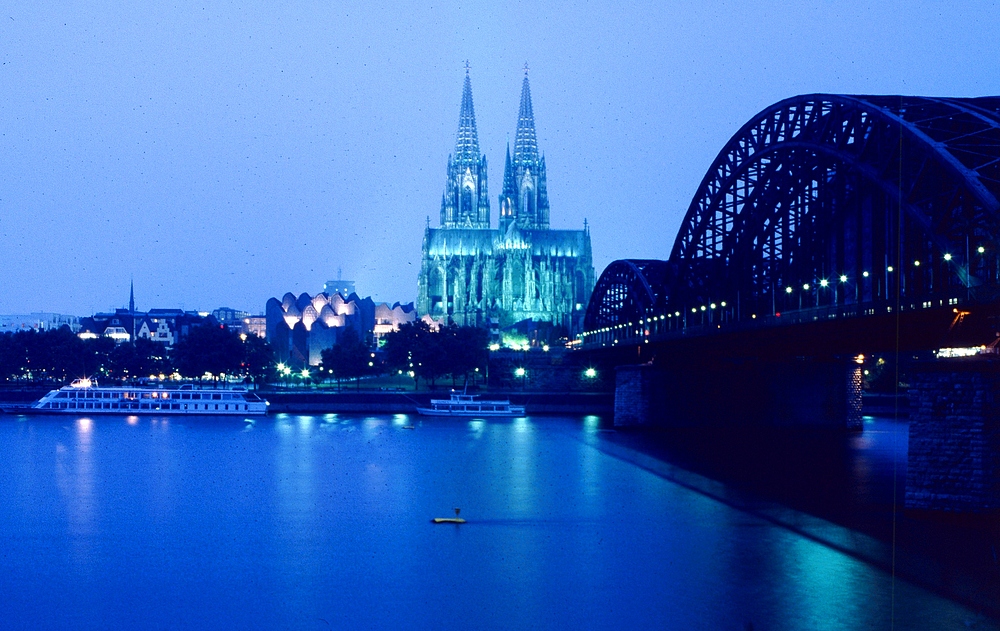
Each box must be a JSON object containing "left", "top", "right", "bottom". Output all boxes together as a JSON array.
[{"left": 260, "top": 391, "right": 614, "bottom": 415}]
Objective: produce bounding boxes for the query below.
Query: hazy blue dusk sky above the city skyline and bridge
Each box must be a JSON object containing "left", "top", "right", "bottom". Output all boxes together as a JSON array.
[{"left": 0, "top": 0, "right": 1000, "bottom": 315}]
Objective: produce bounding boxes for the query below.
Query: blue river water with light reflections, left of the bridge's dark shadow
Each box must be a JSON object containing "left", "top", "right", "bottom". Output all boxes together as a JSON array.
[{"left": 0, "top": 415, "right": 1000, "bottom": 631}]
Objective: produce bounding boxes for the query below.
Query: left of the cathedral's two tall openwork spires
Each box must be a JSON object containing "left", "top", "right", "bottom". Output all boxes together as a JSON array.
[{"left": 441, "top": 62, "right": 490, "bottom": 229}]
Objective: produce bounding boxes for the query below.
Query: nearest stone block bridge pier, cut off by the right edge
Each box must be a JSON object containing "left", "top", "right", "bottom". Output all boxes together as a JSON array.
[{"left": 906, "top": 356, "right": 1000, "bottom": 512}]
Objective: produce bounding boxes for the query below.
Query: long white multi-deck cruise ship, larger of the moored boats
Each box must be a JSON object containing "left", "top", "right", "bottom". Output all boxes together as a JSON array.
[{"left": 31, "top": 379, "right": 268, "bottom": 416}]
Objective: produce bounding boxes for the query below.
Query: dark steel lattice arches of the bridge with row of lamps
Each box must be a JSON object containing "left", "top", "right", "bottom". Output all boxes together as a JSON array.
[{"left": 583, "top": 94, "right": 1000, "bottom": 348}]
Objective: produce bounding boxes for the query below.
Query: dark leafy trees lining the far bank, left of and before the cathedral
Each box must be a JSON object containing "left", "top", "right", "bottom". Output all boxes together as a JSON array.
[{"left": 0, "top": 321, "right": 489, "bottom": 386}]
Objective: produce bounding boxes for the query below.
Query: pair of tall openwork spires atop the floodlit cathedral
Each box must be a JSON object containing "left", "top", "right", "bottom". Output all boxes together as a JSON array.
[{"left": 441, "top": 63, "right": 549, "bottom": 229}]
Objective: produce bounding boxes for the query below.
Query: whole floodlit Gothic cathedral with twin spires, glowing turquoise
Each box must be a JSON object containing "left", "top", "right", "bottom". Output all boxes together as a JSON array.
[{"left": 417, "top": 67, "right": 594, "bottom": 333}]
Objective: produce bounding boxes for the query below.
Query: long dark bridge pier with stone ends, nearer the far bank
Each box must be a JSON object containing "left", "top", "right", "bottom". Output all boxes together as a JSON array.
[{"left": 615, "top": 360, "right": 861, "bottom": 430}]
